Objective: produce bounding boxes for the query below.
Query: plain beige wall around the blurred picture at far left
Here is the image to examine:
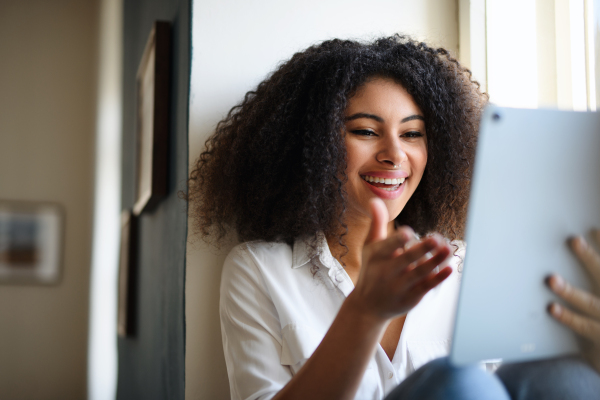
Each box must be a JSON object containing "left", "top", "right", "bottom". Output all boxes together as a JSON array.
[{"left": 0, "top": 0, "right": 97, "bottom": 400}]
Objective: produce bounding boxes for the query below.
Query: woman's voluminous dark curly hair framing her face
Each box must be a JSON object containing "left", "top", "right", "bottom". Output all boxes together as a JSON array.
[{"left": 187, "top": 35, "right": 488, "bottom": 244}]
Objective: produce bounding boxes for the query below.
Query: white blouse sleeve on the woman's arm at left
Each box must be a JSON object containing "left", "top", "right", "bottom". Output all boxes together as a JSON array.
[{"left": 220, "top": 245, "right": 292, "bottom": 400}]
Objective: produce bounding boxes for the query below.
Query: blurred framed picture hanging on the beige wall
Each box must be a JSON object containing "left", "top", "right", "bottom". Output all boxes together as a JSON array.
[{"left": 0, "top": 200, "right": 65, "bottom": 285}]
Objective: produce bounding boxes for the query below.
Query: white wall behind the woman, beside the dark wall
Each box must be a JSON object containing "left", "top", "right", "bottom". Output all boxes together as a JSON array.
[{"left": 186, "top": 0, "right": 458, "bottom": 399}]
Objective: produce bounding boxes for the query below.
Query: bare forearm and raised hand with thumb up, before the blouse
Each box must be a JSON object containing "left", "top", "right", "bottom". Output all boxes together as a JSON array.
[{"left": 274, "top": 199, "right": 452, "bottom": 400}]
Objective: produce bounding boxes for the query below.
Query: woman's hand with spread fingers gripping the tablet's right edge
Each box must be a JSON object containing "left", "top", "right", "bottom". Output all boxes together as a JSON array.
[{"left": 548, "top": 231, "right": 600, "bottom": 373}]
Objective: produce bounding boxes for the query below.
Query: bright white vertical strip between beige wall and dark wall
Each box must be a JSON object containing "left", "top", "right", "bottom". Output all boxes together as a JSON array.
[{"left": 88, "top": 0, "right": 123, "bottom": 400}]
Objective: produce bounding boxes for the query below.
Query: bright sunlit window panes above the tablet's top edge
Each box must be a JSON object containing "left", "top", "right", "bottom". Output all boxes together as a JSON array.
[{"left": 485, "top": 0, "right": 596, "bottom": 111}]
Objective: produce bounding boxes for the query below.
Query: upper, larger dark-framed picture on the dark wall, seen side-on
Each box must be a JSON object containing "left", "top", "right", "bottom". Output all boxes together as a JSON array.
[{"left": 133, "top": 21, "right": 171, "bottom": 215}]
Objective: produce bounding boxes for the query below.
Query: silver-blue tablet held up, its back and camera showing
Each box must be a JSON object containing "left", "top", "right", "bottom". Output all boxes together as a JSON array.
[{"left": 450, "top": 105, "right": 600, "bottom": 365}]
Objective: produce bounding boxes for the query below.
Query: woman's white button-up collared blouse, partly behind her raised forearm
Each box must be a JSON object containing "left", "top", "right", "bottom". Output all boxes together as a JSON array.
[{"left": 220, "top": 235, "right": 462, "bottom": 400}]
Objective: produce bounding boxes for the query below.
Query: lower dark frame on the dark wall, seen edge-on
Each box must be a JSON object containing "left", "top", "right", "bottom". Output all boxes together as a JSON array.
[{"left": 117, "top": 210, "right": 137, "bottom": 337}]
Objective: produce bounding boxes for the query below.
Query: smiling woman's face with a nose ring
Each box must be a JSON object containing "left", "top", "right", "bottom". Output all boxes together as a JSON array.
[{"left": 345, "top": 78, "right": 427, "bottom": 221}]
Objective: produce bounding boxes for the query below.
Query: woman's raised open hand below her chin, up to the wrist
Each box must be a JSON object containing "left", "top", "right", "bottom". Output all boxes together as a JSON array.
[{"left": 352, "top": 198, "right": 452, "bottom": 320}]
